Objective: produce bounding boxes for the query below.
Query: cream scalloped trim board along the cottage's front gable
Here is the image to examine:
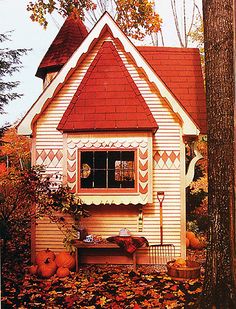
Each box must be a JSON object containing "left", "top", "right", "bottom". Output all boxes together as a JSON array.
[{"left": 18, "top": 13, "right": 200, "bottom": 135}]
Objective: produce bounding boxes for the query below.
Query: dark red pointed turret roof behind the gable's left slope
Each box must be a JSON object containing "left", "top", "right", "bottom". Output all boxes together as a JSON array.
[{"left": 36, "top": 14, "right": 88, "bottom": 78}]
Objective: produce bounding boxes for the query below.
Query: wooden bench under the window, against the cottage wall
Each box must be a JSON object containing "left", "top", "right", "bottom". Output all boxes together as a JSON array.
[{"left": 72, "top": 239, "right": 137, "bottom": 272}]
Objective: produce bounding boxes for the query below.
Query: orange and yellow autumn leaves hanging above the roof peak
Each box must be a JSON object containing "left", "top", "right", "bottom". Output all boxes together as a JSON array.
[{"left": 27, "top": 0, "right": 162, "bottom": 39}]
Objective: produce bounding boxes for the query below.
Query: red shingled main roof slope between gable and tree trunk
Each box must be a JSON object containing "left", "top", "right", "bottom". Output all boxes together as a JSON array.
[{"left": 137, "top": 46, "right": 207, "bottom": 133}]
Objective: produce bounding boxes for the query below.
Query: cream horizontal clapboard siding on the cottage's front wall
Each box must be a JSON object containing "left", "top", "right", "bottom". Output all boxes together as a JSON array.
[{"left": 35, "top": 33, "right": 185, "bottom": 263}]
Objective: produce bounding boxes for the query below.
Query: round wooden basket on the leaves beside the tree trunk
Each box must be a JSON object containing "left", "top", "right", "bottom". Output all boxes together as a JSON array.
[{"left": 167, "top": 260, "right": 200, "bottom": 279}]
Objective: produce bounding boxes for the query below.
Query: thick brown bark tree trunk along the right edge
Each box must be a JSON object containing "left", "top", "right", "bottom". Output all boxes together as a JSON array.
[{"left": 200, "top": 0, "right": 236, "bottom": 309}]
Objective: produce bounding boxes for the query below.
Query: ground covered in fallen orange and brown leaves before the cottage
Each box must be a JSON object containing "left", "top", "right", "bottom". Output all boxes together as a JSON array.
[{"left": 2, "top": 266, "right": 202, "bottom": 309}]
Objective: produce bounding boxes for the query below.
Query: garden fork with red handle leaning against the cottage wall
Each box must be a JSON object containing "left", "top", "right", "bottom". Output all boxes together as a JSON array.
[{"left": 149, "top": 191, "right": 175, "bottom": 264}]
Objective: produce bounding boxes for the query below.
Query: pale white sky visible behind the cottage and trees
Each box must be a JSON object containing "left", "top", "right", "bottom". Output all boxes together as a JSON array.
[{"left": 0, "top": 0, "right": 201, "bottom": 127}]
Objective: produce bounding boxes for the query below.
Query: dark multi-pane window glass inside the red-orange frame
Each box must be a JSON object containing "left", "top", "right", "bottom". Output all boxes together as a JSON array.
[{"left": 80, "top": 151, "right": 135, "bottom": 189}]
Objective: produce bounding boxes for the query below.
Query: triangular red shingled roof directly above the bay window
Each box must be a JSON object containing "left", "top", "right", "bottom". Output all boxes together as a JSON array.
[{"left": 58, "top": 42, "right": 158, "bottom": 131}]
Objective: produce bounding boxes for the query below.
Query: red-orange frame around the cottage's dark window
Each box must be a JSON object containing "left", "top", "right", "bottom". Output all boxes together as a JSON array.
[{"left": 77, "top": 148, "right": 138, "bottom": 195}]
